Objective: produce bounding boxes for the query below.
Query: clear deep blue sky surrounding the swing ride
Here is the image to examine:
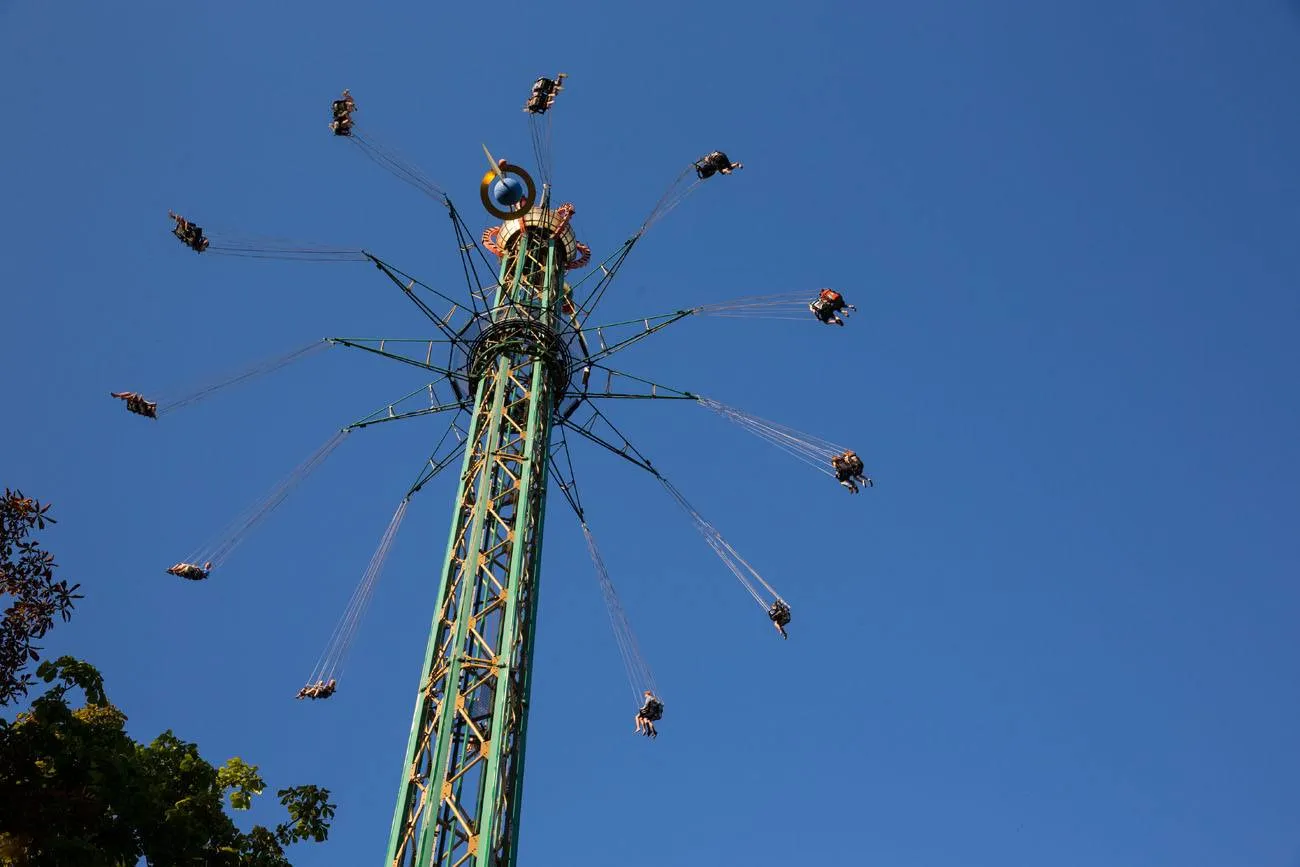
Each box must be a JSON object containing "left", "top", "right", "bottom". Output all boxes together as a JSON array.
[{"left": 0, "top": 0, "right": 1300, "bottom": 867}]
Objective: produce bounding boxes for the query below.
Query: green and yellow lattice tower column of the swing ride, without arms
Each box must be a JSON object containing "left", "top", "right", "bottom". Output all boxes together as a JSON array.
[{"left": 386, "top": 194, "right": 576, "bottom": 867}]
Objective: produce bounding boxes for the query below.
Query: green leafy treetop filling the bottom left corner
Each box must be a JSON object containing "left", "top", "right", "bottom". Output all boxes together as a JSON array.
[{"left": 0, "top": 656, "right": 334, "bottom": 867}]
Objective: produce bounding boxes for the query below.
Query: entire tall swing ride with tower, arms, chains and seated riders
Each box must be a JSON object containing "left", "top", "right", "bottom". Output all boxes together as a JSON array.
[{"left": 137, "top": 75, "right": 871, "bottom": 867}]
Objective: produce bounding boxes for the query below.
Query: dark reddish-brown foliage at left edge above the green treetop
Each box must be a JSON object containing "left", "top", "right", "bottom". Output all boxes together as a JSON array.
[{"left": 0, "top": 487, "right": 82, "bottom": 705}]
